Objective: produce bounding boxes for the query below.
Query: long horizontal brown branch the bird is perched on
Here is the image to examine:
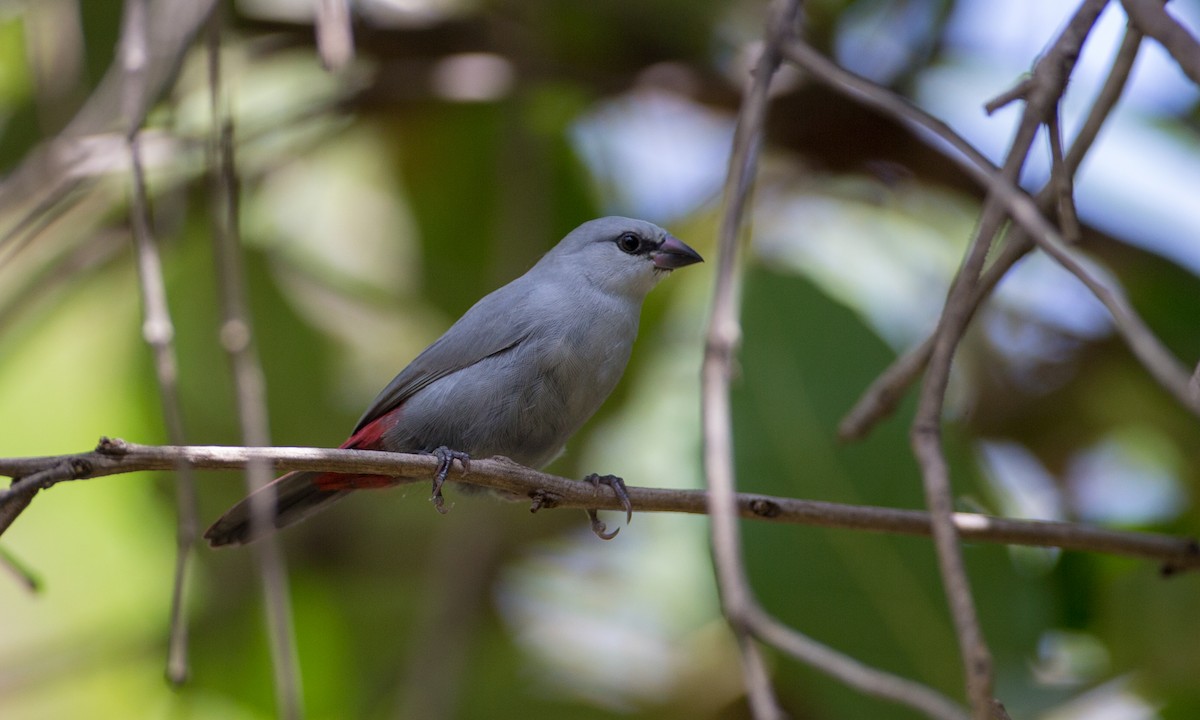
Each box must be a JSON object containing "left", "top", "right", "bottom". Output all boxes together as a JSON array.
[{"left": 0, "top": 438, "right": 1200, "bottom": 575}]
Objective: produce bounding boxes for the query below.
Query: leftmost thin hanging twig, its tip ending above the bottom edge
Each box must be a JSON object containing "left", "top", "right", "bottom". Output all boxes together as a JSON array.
[{"left": 120, "top": 0, "right": 198, "bottom": 685}]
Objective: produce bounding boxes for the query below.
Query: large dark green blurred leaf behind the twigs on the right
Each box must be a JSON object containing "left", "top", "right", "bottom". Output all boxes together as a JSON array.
[{"left": 734, "top": 268, "right": 1065, "bottom": 718}]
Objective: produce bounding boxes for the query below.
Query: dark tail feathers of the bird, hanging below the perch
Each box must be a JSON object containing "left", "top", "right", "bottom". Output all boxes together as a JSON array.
[{"left": 204, "top": 473, "right": 350, "bottom": 547}]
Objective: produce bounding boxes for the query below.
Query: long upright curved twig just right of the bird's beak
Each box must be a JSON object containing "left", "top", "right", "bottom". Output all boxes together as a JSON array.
[{"left": 701, "top": 0, "right": 800, "bottom": 720}]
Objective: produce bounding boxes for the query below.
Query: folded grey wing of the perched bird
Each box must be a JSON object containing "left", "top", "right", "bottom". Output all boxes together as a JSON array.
[{"left": 354, "top": 282, "right": 532, "bottom": 432}]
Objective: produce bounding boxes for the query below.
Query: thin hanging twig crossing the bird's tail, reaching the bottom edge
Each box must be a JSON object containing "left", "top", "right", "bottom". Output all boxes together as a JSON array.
[{"left": 208, "top": 17, "right": 304, "bottom": 720}]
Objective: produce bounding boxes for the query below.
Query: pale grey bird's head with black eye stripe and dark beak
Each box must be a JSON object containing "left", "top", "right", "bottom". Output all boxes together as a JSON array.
[{"left": 545, "top": 217, "right": 704, "bottom": 299}]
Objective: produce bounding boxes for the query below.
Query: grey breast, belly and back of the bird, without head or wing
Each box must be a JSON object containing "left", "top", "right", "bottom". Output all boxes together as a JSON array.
[{"left": 386, "top": 275, "right": 641, "bottom": 467}]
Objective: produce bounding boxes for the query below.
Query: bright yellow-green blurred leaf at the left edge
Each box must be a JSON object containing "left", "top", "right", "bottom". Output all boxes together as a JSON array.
[{"left": 0, "top": 265, "right": 174, "bottom": 718}]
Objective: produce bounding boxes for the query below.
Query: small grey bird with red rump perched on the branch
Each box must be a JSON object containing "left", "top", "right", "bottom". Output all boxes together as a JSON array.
[{"left": 204, "top": 216, "right": 703, "bottom": 547}]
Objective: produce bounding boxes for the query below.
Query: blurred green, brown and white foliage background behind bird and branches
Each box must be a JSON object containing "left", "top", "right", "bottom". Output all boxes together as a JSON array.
[{"left": 0, "top": 0, "right": 1200, "bottom": 720}]
